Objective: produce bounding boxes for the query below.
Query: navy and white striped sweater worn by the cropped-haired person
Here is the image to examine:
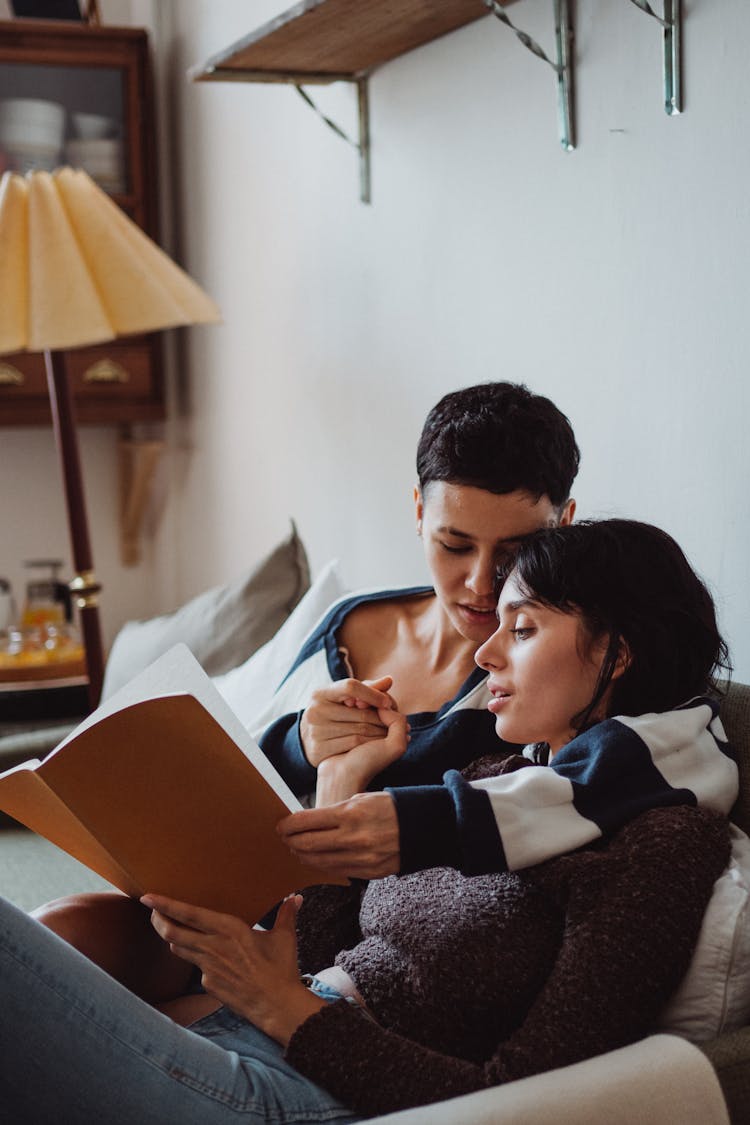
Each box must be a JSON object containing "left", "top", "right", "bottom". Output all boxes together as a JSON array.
[{"left": 260, "top": 587, "right": 738, "bottom": 874}]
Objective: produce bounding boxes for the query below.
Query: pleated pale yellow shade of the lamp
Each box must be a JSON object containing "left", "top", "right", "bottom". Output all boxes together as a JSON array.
[{"left": 0, "top": 168, "right": 222, "bottom": 354}]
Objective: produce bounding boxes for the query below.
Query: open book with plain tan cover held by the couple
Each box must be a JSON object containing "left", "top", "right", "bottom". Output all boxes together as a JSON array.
[{"left": 0, "top": 645, "right": 346, "bottom": 923}]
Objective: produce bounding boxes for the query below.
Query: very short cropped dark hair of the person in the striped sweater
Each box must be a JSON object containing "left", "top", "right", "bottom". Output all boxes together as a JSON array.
[{"left": 417, "top": 383, "right": 580, "bottom": 509}]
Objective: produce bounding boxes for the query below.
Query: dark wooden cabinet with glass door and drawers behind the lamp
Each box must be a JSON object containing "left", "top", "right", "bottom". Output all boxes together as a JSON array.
[{"left": 0, "top": 19, "right": 164, "bottom": 426}]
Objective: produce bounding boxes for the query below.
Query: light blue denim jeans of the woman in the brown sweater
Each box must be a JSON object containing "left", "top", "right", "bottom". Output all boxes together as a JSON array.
[{"left": 0, "top": 899, "right": 360, "bottom": 1125}]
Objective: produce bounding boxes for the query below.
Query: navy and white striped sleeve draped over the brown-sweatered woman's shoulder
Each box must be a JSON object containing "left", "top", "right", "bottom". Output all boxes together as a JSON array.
[{"left": 389, "top": 700, "right": 738, "bottom": 875}]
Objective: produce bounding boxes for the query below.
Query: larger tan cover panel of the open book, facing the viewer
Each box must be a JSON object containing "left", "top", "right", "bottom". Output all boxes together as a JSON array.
[{"left": 37, "top": 694, "right": 347, "bottom": 923}]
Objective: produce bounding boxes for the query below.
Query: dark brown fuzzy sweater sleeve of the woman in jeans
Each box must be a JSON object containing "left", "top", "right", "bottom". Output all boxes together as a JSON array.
[{"left": 287, "top": 809, "right": 729, "bottom": 1116}]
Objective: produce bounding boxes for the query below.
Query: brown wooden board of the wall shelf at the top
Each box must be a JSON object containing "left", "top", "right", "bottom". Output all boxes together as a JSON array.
[{"left": 190, "top": 0, "right": 501, "bottom": 83}]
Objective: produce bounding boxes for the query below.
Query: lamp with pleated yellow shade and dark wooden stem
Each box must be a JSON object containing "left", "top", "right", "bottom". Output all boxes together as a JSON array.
[{"left": 0, "top": 168, "right": 220, "bottom": 707}]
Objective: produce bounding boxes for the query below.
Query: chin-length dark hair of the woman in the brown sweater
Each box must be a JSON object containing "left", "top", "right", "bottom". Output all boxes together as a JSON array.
[{"left": 498, "top": 520, "right": 729, "bottom": 730}]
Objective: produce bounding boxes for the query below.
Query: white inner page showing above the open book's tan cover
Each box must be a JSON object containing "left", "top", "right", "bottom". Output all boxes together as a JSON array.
[{"left": 45, "top": 645, "right": 302, "bottom": 812}]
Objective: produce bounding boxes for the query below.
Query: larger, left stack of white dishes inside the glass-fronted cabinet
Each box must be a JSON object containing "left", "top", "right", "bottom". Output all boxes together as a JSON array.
[{"left": 0, "top": 98, "right": 65, "bottom": 172}]
